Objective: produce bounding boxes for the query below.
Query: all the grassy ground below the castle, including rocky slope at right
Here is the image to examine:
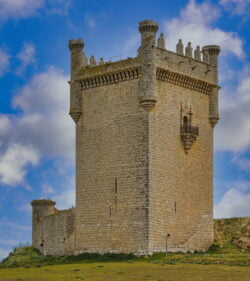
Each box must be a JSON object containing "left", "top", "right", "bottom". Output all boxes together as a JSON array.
[{"left": 0, "top": 218, "right": 250, "bottom": 281}]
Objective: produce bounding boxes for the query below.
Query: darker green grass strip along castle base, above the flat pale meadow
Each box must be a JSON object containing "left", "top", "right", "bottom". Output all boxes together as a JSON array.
[{"left": 0, "top": 244, "right": 250, "bottom": 268}]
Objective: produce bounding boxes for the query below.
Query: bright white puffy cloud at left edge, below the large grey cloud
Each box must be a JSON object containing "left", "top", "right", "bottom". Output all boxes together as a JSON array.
[{"left": 0, "top": 143, "right": 39, "bottom": 185}]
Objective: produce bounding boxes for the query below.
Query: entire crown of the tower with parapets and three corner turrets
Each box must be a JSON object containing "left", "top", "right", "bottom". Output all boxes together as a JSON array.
[{"left": 69, "top": 20, "right": 220, "bottom": 127}]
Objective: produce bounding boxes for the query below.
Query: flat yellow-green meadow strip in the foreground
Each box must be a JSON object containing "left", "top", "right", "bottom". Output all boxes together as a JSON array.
[{"left": 0, "top": 261, "right": 250, "bottom": 281}]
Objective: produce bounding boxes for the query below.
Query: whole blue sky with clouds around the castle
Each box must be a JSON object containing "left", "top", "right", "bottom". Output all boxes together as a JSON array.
[{"left": 0, "top": 0, "right": 250, "bottom": 259}]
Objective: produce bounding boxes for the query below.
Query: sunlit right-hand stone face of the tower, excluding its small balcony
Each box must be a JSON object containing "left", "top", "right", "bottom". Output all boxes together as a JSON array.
[{"left": 149, "top": 81, "right": 213, "bottom": 252}]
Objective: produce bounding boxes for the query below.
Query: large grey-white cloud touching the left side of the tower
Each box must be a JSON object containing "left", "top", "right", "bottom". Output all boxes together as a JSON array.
[{"left": 13, "top": 68, "right": 75, "bottom": 160}]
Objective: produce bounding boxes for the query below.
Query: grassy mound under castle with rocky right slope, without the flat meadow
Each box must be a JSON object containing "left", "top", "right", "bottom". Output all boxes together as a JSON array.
[{"left": 0, "top": 215, "right": 250, "bottom": 268}]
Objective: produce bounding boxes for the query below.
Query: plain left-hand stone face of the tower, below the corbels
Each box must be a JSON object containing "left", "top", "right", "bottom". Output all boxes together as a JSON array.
[{"left": 76, "top": 79, "right": 148, "bottom": 254}]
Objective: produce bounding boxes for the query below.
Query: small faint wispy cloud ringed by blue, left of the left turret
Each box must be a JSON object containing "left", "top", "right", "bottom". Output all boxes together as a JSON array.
[{"left": 16, "top": 43, "right": 36, "bottom": 75}]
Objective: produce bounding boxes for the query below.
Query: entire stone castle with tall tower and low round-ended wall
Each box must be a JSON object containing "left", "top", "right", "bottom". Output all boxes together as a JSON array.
[{"left": 31, "top": 20, "right": 220, "bottom": 255}]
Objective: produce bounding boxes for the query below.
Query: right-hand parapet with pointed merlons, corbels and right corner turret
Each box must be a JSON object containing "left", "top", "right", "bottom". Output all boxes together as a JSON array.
[{"left": 156, "top": 39, "right": 220, "bottom": 127}]
